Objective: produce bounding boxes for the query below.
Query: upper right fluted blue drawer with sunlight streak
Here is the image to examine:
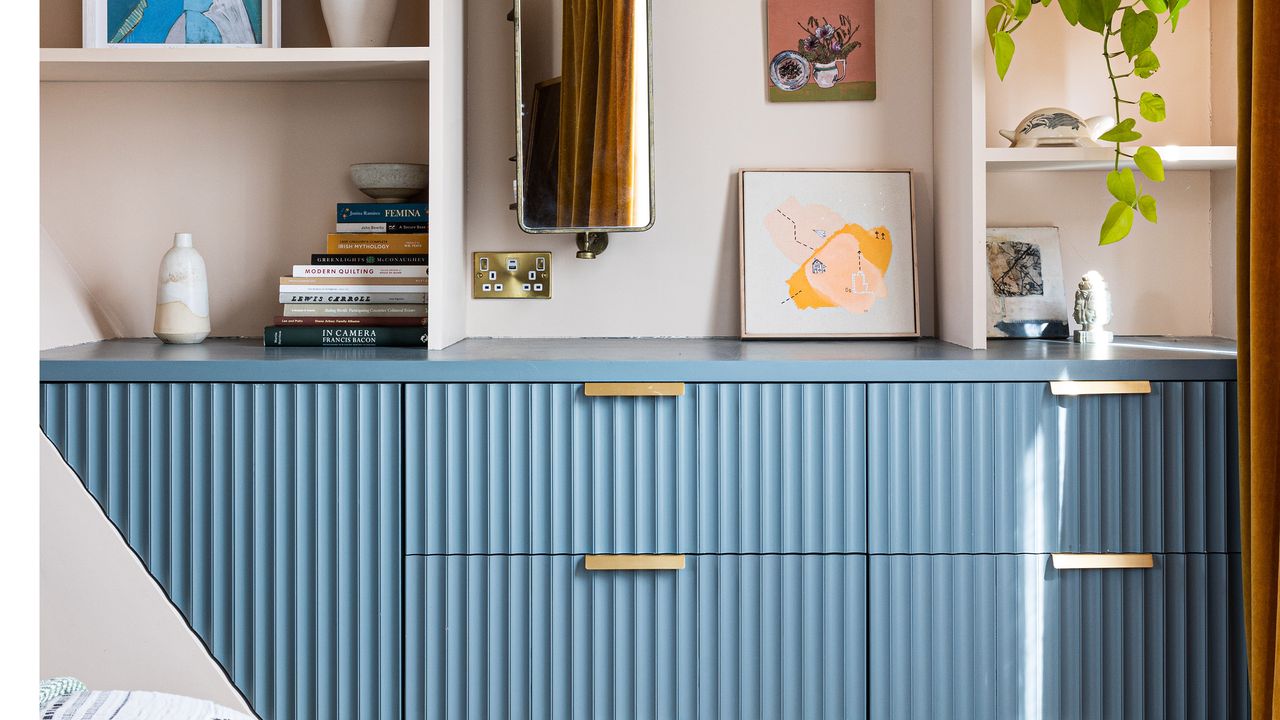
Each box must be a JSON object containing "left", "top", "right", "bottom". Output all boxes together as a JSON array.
[{"left": 868, "top": 382, "right": 1239, "bottom": 553}]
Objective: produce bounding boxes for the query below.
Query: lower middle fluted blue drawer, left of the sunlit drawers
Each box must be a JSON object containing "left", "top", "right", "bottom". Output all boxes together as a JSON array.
[{"left": 406, "top": 555, "right": 867, "bottom": 720}]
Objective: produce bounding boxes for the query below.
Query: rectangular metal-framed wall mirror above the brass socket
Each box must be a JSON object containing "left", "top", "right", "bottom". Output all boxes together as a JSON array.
[{"left": 512, "top": 0, "right": 654, "bottom": 233}]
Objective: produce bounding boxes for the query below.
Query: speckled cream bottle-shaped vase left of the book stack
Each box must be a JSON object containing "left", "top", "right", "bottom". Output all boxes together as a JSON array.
[{"left": 154, "top": 232, "right": 210, "bottom": 345}]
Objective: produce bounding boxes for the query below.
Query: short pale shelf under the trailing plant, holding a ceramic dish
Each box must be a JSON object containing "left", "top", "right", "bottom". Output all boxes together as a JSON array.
[{"left": 986, "top": 146, "right": 1235, "bottom": 173}]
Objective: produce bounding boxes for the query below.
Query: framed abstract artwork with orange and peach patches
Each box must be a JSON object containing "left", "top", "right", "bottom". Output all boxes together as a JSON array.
[{"left": 739, "top": 170, "right": 920, "bottom": 338}]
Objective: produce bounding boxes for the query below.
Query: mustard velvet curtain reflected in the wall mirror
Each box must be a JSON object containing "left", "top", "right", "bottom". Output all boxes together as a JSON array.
[{"left": 557, "top": 0, "right": 636, "bottom": 227}]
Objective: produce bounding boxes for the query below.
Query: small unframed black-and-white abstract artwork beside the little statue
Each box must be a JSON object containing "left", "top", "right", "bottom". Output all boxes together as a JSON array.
[{"left": 987, "top": 228, "right": 1070, "bottom": 338}]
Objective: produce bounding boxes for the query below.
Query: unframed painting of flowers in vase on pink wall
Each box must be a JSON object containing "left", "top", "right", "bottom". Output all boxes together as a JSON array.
[{"left": 765, "top": 0, "right": 876, "bottom": 102}]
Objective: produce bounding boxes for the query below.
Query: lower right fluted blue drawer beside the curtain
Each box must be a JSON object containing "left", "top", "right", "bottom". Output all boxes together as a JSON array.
[{"left": 869, "top": 553, "right": 1248, "bottom": 720}]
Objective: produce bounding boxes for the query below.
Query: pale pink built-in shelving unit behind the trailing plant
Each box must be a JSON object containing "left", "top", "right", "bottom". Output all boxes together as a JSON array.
[{"left": 933, "top": 0, "right": 1236, "bottom": 348}]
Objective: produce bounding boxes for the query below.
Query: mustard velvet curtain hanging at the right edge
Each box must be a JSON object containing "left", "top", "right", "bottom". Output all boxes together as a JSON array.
[{"left": 1236, "top": 0, "right": 1280, "bottom": 719}]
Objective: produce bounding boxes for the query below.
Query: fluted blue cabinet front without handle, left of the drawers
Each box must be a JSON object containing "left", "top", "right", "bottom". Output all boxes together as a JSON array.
[{"left": 41, "top": 383, "right": 403, "bottom": 720}]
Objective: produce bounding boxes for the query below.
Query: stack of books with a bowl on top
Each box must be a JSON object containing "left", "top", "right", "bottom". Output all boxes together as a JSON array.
[{"left": 262, "top": 202, "right": 428, "bottom": 347}]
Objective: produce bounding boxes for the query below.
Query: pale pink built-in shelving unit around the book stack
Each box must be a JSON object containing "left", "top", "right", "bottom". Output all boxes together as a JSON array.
[{"left": 40, "top": 0, "right": 467, "bottom": 348}]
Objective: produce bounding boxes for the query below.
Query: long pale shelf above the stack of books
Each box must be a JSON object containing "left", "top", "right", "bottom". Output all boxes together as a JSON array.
[{"left": 40, "top": 46, "right": 431, "bottom": 82}]
